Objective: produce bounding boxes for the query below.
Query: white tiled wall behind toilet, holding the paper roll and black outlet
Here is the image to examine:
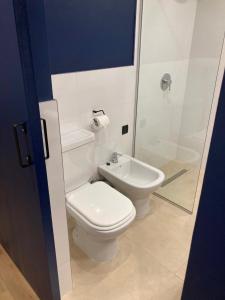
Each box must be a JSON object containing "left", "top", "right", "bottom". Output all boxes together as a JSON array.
[{"left": 52, "top": 66, "right": 136, "bottom": 166}]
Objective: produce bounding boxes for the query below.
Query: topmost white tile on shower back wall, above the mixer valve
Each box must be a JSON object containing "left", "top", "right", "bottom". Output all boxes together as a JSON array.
[{"left": 141, "top": 0, "right": 197, "bottom": 63}]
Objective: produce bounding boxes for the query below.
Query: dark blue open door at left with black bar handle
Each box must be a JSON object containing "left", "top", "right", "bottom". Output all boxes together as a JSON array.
[{"left": 0, "top": 0, "right": 60, "bottom": 300}]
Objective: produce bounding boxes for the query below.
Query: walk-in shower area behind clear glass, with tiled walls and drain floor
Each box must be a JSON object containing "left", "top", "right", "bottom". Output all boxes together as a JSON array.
[{"left": 135, "top": 0, "right": 225, "bottom": 212}]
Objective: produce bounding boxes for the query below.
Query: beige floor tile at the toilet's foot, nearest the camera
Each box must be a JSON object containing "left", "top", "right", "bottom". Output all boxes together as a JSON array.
[{"left": 63, "top": 236, "right": 183, "bottom": 300}]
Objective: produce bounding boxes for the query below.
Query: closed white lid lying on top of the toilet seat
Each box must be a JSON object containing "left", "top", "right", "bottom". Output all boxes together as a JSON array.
[{"left": 67, "top": 182, "right": 133, "bottom": 227}]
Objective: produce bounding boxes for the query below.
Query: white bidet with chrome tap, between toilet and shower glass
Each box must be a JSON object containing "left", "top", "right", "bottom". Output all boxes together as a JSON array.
[{"left": 98, "top": 155, "right": 165, "bottom": 219}]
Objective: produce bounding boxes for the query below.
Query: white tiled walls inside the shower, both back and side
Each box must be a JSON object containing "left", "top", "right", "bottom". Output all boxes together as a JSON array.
[{"left": 136, "top": 0, "right": 225, "bottom": 166}]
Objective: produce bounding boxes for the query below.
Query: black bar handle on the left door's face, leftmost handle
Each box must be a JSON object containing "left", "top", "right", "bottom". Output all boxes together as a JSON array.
[{"left": 13, "top": 122, "right": 33, "bottom": 168}]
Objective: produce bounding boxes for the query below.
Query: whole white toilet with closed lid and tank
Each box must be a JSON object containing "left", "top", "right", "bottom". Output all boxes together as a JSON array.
[{"left": 62, "top": 129, "right": 136, "bottom": 261}]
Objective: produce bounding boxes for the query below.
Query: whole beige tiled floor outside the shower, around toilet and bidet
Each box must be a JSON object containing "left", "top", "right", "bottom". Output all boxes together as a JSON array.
[{"left": 63, "top": 196, "right": 195, "bottom": 300}]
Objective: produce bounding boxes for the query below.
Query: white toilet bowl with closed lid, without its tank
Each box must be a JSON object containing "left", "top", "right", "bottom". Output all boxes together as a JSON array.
[{"left": 66, "top": 182, "right": 136, "bottom": 261}]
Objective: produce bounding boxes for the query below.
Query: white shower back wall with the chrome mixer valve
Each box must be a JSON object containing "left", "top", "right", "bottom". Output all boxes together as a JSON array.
[{"left": 136, "top": 0, "right": 197, "bottom": 167}]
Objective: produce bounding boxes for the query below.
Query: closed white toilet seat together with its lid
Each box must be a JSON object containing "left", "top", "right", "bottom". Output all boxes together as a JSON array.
[{"left": 66, "top": 182, "right": 136, "bottom": 234}]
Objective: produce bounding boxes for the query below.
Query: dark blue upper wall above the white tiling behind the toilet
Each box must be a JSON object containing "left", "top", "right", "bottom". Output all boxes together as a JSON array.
[{"left": 45, "top": 0, "right": 136, "bottom": 74}]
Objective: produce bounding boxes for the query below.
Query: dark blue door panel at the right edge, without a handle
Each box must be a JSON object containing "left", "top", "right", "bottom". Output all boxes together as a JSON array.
[{"left": 182, "top": 72, "right": 225, "bottom": 300}]
